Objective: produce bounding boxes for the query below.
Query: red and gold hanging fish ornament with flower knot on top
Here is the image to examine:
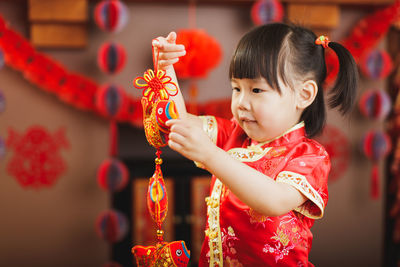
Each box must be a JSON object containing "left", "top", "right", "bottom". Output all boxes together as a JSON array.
[{"left": 132, "top": 40, "right": 190, "bottom": 267}]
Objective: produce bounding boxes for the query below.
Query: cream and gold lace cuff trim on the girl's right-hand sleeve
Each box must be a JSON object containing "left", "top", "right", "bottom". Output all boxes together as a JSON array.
[{"left": 276, "top": 171, "right": 324, "bottom": 219}]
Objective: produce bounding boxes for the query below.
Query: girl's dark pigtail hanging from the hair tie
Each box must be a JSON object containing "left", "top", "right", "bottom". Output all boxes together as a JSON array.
[{"left": 328, "top": 42, "right": 358, "bottom": 114}]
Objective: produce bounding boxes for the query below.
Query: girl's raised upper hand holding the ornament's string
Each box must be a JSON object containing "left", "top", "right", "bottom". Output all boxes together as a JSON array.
[{"left": 152, "top": 32, "right": 186, "bottom": 70}]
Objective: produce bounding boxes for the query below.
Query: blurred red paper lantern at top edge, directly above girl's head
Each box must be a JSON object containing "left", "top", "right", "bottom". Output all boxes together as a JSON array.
[{"left": 251, "top": 0, "right": 283, "bottom": 25}]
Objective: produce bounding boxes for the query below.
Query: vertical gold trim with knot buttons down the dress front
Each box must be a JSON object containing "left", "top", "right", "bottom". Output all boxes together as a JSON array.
[{"left": 206, "top": 179, "right": 223, "bottom": 267}]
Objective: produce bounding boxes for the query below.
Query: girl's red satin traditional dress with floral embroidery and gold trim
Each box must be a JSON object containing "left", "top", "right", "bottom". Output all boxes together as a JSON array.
[{"left": 199, "top": 116, "right": 330, "bottom": 267}]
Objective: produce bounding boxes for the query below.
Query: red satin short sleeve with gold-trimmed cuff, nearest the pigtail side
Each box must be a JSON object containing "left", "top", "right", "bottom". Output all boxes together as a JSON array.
[{"left": 276, "top": 142, "right": 331, "bottom": 219}]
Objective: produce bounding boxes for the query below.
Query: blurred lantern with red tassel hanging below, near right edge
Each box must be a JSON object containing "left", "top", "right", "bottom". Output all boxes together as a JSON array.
[{"left": 362, "top": 131, "right": 392, "bottom": 199}]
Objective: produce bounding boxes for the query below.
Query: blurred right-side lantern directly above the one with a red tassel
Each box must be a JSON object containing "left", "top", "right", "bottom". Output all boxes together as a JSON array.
[{"left": 359, "top": 90, "right": 392, "bottom": 119}]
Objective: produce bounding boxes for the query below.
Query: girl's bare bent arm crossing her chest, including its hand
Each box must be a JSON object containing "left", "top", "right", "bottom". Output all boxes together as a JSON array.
[{"left": 167, "top": 119, "right": 307, "bottom": 216}]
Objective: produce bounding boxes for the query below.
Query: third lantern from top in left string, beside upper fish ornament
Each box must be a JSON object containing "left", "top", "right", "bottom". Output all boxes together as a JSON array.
[{"left": 96, "top": 84, "right": 128, "bottom": 118}]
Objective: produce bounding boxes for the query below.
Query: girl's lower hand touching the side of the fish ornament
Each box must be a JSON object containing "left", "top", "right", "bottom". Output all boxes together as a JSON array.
[{"left": 166, "top": 116, "right": 216, "bottom": 165}]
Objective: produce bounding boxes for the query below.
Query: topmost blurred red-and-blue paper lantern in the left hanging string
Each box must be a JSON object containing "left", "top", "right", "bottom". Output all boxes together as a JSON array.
[{"left": 94, "top": 0, "right": 128, "bottom": 32}]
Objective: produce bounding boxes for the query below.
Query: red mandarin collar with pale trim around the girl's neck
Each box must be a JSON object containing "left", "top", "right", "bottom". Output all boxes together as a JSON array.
[{"left": 247, "top": 121, "right": 306, "bottom": 149}]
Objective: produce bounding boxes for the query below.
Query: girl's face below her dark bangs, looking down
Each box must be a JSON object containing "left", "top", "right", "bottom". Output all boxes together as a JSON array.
[{"left": 231, "top": 77, "right": 301, "bottom": 142}]
